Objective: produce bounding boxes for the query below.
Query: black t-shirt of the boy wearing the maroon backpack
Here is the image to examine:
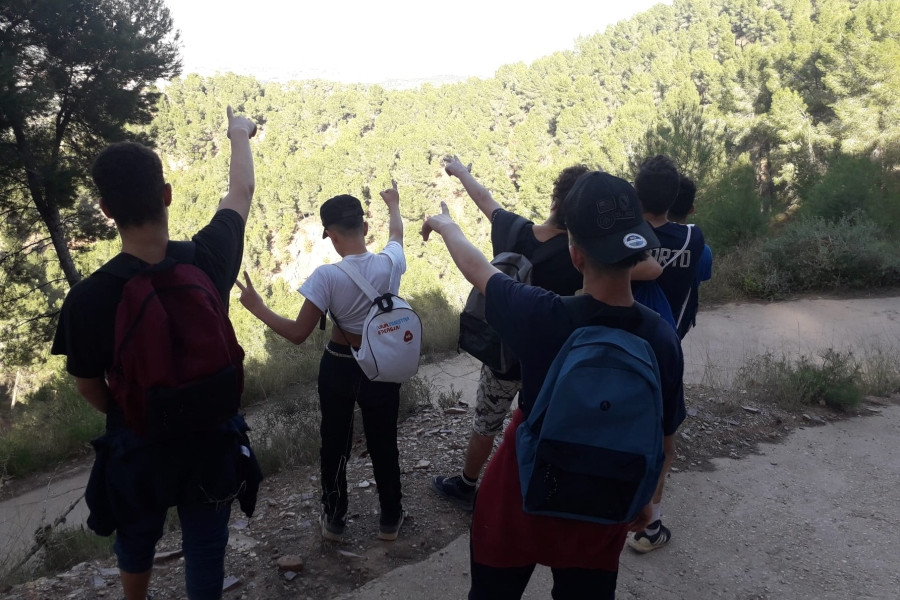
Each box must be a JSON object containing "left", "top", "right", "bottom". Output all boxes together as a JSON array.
[{"left": 50, "top": 209, "right": 244, "bottom": 378}]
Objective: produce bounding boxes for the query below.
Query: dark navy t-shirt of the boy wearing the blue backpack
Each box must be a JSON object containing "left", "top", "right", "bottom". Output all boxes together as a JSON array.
[{"left": 485, "top": 273, "right": 685, "bottom": 435}]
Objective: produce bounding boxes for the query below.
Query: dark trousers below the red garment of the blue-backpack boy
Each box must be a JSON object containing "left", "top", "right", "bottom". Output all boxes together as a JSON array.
[{"left": 469, "top": 553, "right": 618, "bottom": 600}]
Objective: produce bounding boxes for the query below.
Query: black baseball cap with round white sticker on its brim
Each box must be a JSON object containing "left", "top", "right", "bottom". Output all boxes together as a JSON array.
[{"left": 565, "top": 171, "right": 659, "bottom": 264}]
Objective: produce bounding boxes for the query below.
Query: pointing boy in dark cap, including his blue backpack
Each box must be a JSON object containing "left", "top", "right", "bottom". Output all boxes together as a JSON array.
[{"left": 422, "top": 172, "right": 685, "bottom": 600}]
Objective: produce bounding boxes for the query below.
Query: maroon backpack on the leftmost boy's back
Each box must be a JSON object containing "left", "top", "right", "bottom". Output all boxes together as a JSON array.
[{"left": 108, "top": 251, "right": 244, "bottom": 438}]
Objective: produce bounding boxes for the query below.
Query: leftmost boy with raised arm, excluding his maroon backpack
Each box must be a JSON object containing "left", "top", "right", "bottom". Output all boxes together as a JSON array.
[{"left": 52, "top": 106, "right": 259, "bottom": 600}]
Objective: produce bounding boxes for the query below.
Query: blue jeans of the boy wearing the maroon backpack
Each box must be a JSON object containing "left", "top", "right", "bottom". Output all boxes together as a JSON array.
[{"left": 114, "top": 502, "right": 231, "bottom": 600}]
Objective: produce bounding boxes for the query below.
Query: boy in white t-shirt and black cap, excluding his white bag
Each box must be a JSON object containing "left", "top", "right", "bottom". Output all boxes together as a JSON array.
[{"left": 237, "top": 182, "right": 406, "bottom": 541}]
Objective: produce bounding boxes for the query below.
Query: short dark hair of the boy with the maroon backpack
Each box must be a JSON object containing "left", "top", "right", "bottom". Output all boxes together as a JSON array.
[{"left": 91, "top": 142, "right": 166, "bottom": 229}]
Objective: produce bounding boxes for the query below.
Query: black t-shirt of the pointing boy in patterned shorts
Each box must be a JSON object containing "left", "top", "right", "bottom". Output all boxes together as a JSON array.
[{"left": 491, "top": 208, "right": 584, "bottom": 296}]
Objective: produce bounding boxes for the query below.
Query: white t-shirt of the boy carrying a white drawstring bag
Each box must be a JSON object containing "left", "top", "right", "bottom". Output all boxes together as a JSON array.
[{"left": 297, "top": 242, "right": 406, "bottom": 335}]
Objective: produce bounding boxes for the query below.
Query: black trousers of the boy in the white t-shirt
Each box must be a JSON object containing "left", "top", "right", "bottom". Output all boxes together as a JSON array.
[{"left": 319, "top": 342, "right": 403, "bottom": 524}]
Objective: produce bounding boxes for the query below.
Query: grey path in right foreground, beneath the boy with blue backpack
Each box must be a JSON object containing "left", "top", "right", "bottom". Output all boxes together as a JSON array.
[{"left": 341, "top": 398, "right": 900, "bottom": 600}]
